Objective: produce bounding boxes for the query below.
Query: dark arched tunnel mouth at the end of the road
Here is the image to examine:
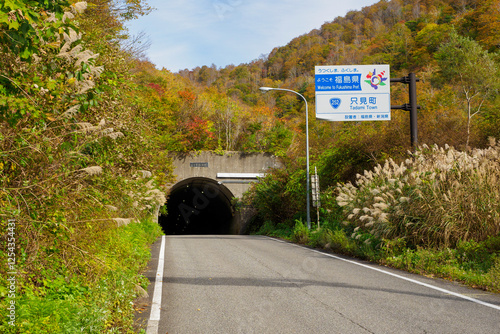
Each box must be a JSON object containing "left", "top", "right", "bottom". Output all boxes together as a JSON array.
[{"left": 158, "top": 177, "right": 236, "bottom": 235}]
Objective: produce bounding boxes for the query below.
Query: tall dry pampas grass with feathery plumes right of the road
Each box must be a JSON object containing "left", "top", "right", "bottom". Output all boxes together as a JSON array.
[{"left": 337, "top": 140, "right": 500, "bottom": 247}]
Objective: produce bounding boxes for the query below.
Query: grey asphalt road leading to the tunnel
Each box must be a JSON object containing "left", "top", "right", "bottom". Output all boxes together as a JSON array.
[{"left": 138, "top": 235, "right": 500, "bottom": 334}]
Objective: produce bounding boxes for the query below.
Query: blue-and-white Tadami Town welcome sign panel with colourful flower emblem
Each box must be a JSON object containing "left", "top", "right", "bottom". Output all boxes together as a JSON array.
[{"left": 315, "top": 65, "right": 391, "bottom": 121}]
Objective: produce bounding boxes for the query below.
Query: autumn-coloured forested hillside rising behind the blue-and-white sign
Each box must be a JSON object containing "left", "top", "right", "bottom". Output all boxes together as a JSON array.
[{"left": 161, "top": 0, "right": 500, "bottom": 185}]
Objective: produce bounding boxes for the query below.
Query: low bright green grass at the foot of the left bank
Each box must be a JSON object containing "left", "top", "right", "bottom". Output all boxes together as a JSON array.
[{"left": 0, "top": 220, "right": 161, "bottom": 334}]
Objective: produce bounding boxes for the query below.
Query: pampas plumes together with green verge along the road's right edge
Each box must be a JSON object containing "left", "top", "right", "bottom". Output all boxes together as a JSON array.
[{"left": 252, "top": 143, "right": 500, "bottom": 292}]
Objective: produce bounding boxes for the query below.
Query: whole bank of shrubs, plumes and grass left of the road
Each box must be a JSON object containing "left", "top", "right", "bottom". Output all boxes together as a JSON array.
[{"left": 0, "top": 1, "right": 167, "bottom": 333}]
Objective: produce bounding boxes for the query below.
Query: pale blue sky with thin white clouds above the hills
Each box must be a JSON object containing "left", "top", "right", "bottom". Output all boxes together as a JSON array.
[{"left": 126, "top": 0, "right": 378, "bottom": 72}]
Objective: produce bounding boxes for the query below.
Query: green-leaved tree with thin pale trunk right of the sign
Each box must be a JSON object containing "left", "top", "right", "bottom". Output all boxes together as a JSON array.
[{"left": 435, "top": 31, "right": 500, "bottom": 146}]
